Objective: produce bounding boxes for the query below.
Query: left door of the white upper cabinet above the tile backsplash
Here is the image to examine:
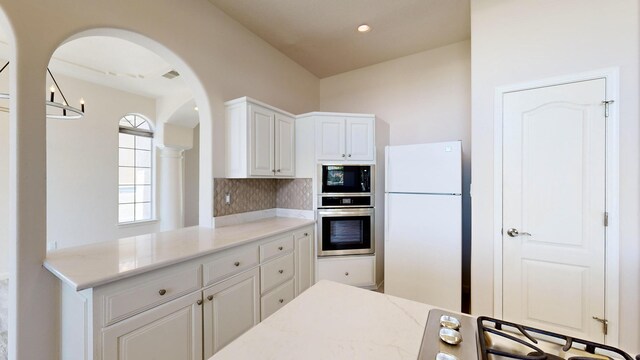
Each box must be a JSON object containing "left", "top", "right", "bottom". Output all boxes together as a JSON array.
[{"left": 249, "top": 104, "right": 275, "bottom": 176}]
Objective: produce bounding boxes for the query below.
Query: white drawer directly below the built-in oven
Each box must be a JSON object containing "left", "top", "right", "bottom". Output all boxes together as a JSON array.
[{"left": 318, "top": 256, "right": 376, "bottom": 286}]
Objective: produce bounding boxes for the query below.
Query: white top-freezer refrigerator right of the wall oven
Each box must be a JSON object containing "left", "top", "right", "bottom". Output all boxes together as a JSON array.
[{"left": 384, "top": 141, "right": 462, "bottom": 311}]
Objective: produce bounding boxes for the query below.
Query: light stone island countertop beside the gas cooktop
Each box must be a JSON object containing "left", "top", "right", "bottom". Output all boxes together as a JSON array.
[{"left": 210, "top": 280, "right": 431, "bottom": 360}]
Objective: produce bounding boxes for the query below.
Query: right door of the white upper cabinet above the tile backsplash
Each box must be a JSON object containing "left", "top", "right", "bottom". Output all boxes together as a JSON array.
[{"left": 275, "top": 113, "right": 296, "bottom": 177}]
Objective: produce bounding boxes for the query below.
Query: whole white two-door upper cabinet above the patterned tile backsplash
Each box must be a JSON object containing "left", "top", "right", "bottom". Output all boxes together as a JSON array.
[{"left": 225, "top": 97, "right": 295, "bottom": 178}]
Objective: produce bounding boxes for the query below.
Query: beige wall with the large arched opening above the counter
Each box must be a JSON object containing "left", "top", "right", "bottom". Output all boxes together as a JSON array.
[{"left": 0, "top": 0, "right": 319, "bottom": 359}]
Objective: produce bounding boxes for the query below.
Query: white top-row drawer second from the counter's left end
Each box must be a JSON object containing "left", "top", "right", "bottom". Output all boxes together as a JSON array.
[{"left": 204, "top": 246, "right": 258, "bottom": 286}]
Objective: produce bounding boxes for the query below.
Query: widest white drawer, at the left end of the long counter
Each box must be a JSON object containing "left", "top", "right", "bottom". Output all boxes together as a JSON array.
[{"left": 103, "top": 266, "right": 200, "bottom": 326}]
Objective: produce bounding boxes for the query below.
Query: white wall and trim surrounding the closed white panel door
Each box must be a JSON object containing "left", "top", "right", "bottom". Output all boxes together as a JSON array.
[{"left": 471, "top": 0, "right": 640, "bottom": 353}]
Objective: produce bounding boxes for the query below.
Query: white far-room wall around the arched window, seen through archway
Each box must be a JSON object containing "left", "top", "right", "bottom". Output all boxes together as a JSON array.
[{"left": 46, "top": 75, "right": 159, "bottom": 249}]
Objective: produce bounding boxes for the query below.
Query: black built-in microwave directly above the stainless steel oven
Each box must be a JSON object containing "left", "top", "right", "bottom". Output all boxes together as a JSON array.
[{"left": 319, "top": 164, "right": 374, "bottom": 194}]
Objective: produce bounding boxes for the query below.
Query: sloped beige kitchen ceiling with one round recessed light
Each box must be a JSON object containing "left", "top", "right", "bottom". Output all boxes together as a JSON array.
[{"left": 209, "top": 0, "right": 471, "bottom": 78}]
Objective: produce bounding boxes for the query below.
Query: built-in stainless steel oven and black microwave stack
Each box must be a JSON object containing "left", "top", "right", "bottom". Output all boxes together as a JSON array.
[{"left": 318, "top": 164, "right": 375, "bottom": 256}]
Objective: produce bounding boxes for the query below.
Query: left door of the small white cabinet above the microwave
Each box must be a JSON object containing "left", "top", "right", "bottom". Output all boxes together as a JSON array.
[{"left": 316, "top": 116, "right": 346, "bottom": 160}]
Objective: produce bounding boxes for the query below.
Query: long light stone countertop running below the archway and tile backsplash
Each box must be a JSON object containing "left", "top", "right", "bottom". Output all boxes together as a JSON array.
[{"left": 44, "top": 217, "right": 314, "bottom": 291}]
